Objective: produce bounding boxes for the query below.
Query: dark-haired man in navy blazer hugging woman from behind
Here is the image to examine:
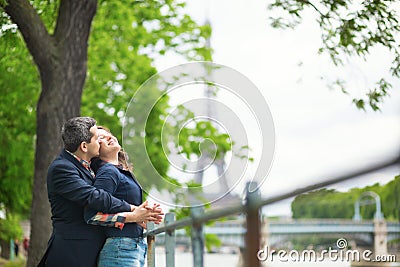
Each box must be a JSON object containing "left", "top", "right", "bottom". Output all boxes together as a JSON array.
[{"left": 39, "top": 117, "right": 160, "bottom": 267}]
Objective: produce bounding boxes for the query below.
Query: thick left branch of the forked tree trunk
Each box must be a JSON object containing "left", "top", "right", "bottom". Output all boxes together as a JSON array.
[{"left": 4, "top": 0, "right": 52, "bottom": 70}]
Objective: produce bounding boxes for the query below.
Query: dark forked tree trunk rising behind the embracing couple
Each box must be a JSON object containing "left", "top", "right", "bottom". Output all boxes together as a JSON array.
[{"left": 5, "top": 0, "right": 97, "bottom": 267}]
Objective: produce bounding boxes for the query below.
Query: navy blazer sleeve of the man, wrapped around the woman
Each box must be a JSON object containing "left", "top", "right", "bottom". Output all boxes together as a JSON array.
[{"left": 48, "top": 161, "right": 131, "bottom": 213}]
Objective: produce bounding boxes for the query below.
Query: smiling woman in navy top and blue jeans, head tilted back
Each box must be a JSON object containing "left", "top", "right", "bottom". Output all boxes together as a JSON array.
[{"left": 85, "top": 127, "right": 162, "bottom": 267}]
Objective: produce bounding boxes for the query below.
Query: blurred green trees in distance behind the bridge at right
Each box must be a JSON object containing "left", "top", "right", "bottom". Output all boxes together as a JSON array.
[{"left": 292, "top": 176, "right": 400, "bottom": 221}]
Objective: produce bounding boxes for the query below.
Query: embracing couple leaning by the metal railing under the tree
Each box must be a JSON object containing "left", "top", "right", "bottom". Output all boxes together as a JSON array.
[{"left": 39, "top": 117, "right": 163, "bottom": 267}]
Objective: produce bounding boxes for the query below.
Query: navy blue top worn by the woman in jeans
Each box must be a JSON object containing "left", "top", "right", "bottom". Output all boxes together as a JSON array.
[{"left": 85, "top": 162, "right": 143, "bottom": 238}]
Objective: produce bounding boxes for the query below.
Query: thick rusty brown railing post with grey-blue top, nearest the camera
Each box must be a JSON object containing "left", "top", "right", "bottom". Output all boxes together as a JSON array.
[{"left": 244, "top": 182, "right": 261, "bottom": 267}]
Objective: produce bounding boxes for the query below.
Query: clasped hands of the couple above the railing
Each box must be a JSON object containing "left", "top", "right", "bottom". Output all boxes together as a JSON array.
[{"left": 121, "top": 200, "right": 164, "bottom": 228}]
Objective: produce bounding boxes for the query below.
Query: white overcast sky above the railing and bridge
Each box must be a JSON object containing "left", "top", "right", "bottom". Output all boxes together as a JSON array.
[{"left": 151, "top": 0, "right": 400, "bottom": 215}]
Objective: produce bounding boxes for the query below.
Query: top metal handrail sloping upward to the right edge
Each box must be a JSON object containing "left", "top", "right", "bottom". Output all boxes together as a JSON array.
[{"left": 144, "top": 157, "right": 400, "bottom": 236}]
